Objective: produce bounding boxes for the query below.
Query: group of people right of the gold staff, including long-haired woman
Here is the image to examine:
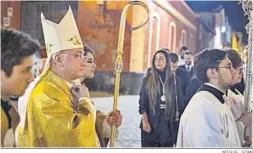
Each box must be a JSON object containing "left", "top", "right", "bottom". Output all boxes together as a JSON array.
[{"left": 139, "top": 46, "right": 252, "bottom": 147}]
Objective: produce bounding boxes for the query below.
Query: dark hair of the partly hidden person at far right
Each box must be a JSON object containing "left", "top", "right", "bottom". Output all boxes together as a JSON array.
[{"left": 226, "top": 49, "right": 242, "bottom": 69}]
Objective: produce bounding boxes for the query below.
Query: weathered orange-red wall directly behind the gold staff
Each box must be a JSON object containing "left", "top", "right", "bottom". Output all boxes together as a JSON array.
[{"left": 77, "top": 1, "right": 132, "bottom": 71}]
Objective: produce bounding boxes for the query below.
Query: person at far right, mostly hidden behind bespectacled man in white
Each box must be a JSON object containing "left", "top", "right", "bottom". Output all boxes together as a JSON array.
[{"left": 227, "top": 49, "right": 252, "bottom": 147}]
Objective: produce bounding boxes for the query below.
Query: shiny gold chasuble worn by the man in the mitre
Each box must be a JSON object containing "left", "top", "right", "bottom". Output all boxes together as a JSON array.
[{"left": 18, "top": 71, "right": 97, "bottom": 147}]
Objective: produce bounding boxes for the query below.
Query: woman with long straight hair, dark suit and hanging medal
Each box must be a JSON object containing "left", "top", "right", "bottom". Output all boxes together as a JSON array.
[{"left": 139, "top": 50, "right": 184, "bottom": 147}]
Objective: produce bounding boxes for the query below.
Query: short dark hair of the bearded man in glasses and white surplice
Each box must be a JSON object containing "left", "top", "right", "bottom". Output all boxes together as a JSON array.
[{"left": 194, "top": 49, "right": 227, "bottom": 83}]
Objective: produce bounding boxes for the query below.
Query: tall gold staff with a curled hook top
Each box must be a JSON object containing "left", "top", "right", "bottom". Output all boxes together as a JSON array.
[{"left": 110, "top": 1, "right": 149, "bottom": 147}]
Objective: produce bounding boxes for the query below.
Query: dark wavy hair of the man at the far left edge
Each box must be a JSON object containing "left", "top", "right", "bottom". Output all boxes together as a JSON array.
[{"left": 1, "top": 29, "right": 40, "bottom": 77}]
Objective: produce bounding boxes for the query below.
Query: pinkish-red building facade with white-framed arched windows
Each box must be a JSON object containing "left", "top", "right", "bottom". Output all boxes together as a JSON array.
[{"left": 144, "top": 0, "right": 198, "bottom": 69}]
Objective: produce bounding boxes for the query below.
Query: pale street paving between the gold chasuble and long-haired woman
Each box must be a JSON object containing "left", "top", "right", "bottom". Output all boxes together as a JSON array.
[{"left": 93, "top": 96, "right": 141, "bottom": 148}]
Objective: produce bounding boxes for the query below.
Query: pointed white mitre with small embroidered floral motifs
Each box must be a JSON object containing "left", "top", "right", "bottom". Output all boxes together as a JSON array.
[{"left": 41, "top": 6, "right": 83, "bottom": 57}]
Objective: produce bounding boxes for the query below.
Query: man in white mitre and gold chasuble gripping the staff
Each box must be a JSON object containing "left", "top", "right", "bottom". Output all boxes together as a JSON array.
[{"left": 17, "top": 8, "right": 121, "bottom": 147}]
